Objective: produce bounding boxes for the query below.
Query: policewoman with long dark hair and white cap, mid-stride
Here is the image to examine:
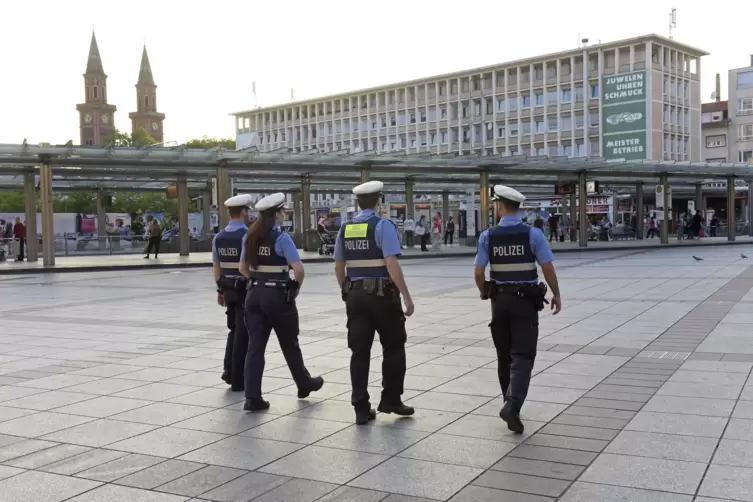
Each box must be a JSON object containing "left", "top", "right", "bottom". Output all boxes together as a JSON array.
[{"left": 240, "top": 193, "right": 324, "bottom": 411}]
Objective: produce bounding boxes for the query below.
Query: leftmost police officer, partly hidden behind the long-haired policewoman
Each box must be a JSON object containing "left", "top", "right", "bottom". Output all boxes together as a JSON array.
[{"left": 212, "top": 194, "right": 253, "bottom": 391}]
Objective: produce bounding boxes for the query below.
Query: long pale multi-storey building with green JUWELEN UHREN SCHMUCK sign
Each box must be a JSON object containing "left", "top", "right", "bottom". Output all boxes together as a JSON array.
[{"left": 233, "top": 35, "right": 707, "bottom": 161}]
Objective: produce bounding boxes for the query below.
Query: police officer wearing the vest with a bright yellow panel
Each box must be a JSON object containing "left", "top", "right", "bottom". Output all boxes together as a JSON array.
[{"left": 335, "top": 181, "right": 414, "bottom": 425}]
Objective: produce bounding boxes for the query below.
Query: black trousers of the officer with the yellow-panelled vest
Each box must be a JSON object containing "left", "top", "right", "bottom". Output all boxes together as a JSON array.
[{"left": 346, "top": 289, "right": 408, "bottom": 410}]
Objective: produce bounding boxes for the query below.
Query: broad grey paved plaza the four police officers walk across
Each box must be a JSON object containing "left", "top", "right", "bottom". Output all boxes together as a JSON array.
[{"left": 0, "top": 249, "right": 753, "bottom": 502}]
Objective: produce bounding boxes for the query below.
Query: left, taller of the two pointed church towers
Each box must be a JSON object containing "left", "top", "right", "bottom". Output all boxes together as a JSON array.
[{"left": 76, "top": 32, "right": 117, "bottom": 146}]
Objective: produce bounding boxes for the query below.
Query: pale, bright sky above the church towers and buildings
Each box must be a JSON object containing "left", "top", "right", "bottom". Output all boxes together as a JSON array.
[{"left": 0, "top": 0, "right": 753, "bottom": 144}]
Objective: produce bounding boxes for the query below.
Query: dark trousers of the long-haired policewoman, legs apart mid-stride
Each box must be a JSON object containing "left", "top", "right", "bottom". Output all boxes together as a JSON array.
[{"left": 245, "top": 286, "right": 311, "bottom": 399}]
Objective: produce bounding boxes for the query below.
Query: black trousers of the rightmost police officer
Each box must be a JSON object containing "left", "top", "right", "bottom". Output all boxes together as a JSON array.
[{"left": 489, "top": 292, "right": 539, "bottom": 411}]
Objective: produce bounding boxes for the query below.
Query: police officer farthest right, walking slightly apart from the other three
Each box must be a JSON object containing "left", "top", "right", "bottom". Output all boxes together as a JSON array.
[{"left": 474, "top": 185, "right": 562, "bottom": 433}]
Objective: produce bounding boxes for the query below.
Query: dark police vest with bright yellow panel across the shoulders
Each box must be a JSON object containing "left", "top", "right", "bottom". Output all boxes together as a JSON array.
[{"left": 341, "top": 215, "right": 390, "bottom": 279}]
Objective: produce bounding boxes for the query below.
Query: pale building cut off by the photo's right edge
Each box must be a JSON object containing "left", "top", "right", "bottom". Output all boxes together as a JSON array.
[{"left": 729, "top": 55, "right": 753, "bottom": 163}]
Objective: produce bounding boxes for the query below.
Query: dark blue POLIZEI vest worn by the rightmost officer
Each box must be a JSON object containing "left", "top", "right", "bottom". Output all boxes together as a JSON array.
[{"left": 488, "top": 223, "right": 539, "bottom": 282}]
